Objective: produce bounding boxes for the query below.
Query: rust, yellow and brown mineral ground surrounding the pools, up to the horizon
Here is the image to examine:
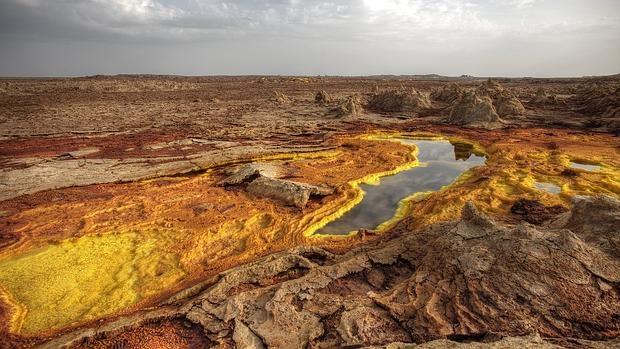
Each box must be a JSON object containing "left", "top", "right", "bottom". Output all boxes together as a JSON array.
[{"left": 0, "top": 76, "right": 620, "bottom": 348}]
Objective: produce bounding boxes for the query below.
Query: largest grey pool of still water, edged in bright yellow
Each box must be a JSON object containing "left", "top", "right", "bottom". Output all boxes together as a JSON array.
[{"left": 317, "top": 139, "right": 486, "bottom": 235}]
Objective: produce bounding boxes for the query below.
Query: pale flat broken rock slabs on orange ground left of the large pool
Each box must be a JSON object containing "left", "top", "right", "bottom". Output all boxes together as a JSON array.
[{"left": 219, "top": 163, "right": 334, "bottom": 209}]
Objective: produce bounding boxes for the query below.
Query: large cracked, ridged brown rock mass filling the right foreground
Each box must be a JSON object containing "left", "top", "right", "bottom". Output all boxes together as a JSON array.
[{"left": 42, "top": 196, "right": 620, "bottom": 348}]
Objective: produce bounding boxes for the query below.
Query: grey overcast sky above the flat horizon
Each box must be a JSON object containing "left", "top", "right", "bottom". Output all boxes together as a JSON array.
[{"left": 0, "top": 0, "right": 620, "bottom": 77}]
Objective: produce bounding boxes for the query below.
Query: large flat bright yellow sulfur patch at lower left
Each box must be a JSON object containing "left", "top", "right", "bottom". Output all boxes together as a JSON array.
[{"left": 0, "top": 232, "right": 184, "bottom": 334}]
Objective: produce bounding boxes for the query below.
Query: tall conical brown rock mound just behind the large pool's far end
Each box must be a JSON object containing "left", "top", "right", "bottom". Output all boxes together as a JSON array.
[{"left": 446, "top": 91, "right": 501, "bottom": 128}]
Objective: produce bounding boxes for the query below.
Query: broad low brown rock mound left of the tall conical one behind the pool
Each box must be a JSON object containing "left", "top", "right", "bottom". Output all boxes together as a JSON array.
[{"left": 368, "top": 88, "right": 431, "bottom": 112}]
